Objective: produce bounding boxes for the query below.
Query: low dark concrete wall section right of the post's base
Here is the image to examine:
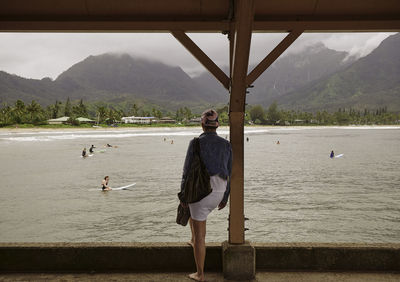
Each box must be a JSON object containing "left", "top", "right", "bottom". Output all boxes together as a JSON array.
[{"left": 253, "top": 243, "right": 400, "bottom": 271}]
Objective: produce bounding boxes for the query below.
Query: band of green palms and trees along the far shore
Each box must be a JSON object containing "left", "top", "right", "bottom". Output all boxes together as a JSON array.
[{"left": 0, "top": 98, "right": 400, "bottom": 126}]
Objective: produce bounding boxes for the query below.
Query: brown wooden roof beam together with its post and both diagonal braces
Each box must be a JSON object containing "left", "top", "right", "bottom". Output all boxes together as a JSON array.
[{"left": 0, "top": 0, "right": 400, "bottom": 244}]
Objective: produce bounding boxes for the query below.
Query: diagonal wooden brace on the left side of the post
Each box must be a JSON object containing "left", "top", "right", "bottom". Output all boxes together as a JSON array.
[{"left": 171, "top": 30, "right": 229, "bottom": 89}]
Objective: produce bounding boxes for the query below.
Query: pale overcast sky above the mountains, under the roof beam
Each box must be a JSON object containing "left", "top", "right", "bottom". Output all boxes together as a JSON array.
[{"left": 0, "top": 33, "right": 393, "bottom": 79}]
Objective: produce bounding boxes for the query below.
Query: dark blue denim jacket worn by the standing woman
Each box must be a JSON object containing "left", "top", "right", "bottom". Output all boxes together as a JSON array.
[{"left": 181, "top": 132, "right": 232, "bottom": 204}]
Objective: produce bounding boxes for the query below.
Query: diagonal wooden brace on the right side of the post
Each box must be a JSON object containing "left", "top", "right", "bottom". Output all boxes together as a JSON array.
[{"left": 246, "top": 29, "right": 303, "bottom": 85}]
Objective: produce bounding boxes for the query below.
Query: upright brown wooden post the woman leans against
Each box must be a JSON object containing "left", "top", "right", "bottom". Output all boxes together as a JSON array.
[{"left": 229, "top": 0, "right": 254, "bottom": 244}]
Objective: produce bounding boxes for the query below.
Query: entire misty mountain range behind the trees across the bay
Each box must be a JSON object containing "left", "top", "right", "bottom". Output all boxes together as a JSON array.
[{"left": 0, "top": 33, "right": 400, "bottom": 111}]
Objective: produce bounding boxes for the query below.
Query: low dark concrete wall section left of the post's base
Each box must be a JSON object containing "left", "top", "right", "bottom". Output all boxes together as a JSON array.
[{"left": 0, "top": 243, "right": 222, "bottom": 272}]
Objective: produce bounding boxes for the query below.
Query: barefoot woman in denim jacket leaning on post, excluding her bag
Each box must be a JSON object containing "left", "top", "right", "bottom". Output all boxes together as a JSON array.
[{"left": 181, "top": 110, "right": 232, "bottom": 281}]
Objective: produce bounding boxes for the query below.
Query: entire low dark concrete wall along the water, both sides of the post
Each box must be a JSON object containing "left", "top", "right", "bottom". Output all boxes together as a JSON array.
[{"left": 0, "top": 243, "right": 400, "bottom": 272}]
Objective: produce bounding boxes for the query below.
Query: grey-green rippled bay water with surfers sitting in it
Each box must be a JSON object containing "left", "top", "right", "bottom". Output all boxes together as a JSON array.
[{"left": 0, "top": 127, "right": 400, "bottom": 243}]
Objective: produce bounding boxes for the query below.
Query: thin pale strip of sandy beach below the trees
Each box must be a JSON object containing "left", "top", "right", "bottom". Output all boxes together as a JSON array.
[{"left": 0, "top": 125, "right": 400, "bottom": 133}]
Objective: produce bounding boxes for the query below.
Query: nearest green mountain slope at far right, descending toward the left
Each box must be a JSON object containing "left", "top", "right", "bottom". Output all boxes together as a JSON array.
[{"left": 277, "top": 33, "right": 400, "bottom": 111}]
